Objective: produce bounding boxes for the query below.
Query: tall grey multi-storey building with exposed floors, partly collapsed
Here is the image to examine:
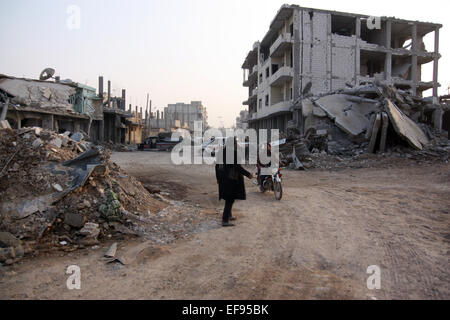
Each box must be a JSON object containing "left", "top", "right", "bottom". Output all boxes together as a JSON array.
[{"left": 242, "top": 5, "right": 442, "bottom": 133}]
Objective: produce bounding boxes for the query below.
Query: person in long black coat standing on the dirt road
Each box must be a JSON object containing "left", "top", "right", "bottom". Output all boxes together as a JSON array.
[{"left": 216, "top": 137, "right": 253, "bottom": 227}]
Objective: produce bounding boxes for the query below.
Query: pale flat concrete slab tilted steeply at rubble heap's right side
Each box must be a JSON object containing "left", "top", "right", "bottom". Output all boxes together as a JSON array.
[{"left": 385, "top": 99, "right": 429, "bottom": 150}]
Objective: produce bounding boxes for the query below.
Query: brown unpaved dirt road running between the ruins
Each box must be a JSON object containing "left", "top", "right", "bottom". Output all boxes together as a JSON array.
[{"left": 0, "top": 152, "right": 450, "bottom": 299}]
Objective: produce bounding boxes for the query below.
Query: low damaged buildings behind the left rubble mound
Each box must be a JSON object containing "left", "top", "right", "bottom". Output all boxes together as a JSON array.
[{"left": 0, "top": 75, "right": 144, "bottom": 144}]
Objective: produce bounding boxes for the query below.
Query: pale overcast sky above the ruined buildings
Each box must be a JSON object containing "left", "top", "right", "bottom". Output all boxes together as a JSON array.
[{"left": 0, "top": 0, "right": 450, "bottom": 126}]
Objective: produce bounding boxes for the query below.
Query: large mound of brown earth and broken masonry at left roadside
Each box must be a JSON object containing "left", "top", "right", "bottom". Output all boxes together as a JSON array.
[{"left": 0, "top": 127, "right": 167, "bottom": 264}]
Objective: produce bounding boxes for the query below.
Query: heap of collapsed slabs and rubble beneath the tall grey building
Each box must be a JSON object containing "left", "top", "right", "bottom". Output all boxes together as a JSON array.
[{"left": 280, "top": 83, "right": 450, "bottom": 169}]
